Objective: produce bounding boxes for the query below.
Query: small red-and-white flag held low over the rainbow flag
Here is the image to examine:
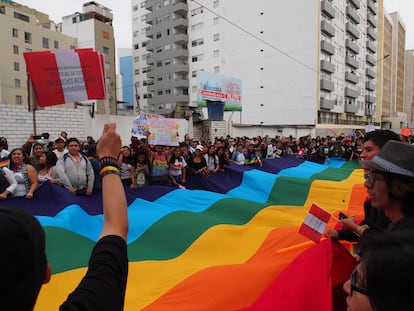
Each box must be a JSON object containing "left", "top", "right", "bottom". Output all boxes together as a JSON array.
[{"left": 299, "top": 204, "right": 331, "bottom": 243}]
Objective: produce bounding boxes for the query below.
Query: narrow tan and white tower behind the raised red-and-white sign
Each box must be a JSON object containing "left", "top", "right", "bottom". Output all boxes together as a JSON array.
[{"left": 62, "top": 1, "right": 117, "bottom": 114}]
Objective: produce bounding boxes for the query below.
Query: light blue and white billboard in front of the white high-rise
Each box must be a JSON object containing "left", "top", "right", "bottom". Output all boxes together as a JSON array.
[{"left": 197, "top": 71, "right": 242, "bottom": 111}]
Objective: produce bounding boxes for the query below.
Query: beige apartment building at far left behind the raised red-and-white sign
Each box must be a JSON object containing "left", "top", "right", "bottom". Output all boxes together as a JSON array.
[{"left": 0, "top": 0, "right": 77, "bottom": 106}]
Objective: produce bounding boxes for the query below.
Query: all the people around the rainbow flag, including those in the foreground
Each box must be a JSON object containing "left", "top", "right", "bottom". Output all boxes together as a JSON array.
[{"left": 0, "top": 128, "right": 414, "bottom": 311}]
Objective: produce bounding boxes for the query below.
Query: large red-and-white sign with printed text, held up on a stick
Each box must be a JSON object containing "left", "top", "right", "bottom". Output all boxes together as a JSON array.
[{"left": 24, "top": 49, "right": 106, "bottom": 107}]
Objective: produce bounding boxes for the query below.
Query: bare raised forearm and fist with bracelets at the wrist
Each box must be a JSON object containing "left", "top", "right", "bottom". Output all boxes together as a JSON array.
[{"left": 96, "top": 123, "right": 128, "bottom": 240}]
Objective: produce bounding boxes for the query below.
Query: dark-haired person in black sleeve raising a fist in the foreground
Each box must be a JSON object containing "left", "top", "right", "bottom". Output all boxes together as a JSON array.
[{"left": 0, "top": 123, "right": 128, "bottom": 311}]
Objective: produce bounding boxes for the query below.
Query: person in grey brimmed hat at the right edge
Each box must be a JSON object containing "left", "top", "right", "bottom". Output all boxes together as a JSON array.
[{"left": 342, "top": 140, "right": 414, "bottom": 235}]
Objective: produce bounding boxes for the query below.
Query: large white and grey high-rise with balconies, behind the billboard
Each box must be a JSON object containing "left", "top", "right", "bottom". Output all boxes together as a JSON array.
[{"left": 132, "top": 0, "right": 382, "bottom": 133}]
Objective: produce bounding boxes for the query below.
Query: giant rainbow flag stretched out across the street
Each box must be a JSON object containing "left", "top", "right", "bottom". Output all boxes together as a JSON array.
[{"left": 0, "top": 157, "right": 366, "bottom": 311}]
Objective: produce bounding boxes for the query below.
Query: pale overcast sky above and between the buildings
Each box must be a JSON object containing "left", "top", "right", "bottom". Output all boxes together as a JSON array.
[{"left": 16, "top": 0, "right": 414, "bottom": 50}]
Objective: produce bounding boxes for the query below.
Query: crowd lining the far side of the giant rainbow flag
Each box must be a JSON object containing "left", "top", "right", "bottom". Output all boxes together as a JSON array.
[{"left": 0, "top": 131, "right": 411, "bottom": 199}]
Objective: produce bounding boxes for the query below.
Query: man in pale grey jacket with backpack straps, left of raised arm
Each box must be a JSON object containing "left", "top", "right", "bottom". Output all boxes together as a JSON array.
[{"left": 56, "top": 138, "right": 95, "bottom": 196}]
